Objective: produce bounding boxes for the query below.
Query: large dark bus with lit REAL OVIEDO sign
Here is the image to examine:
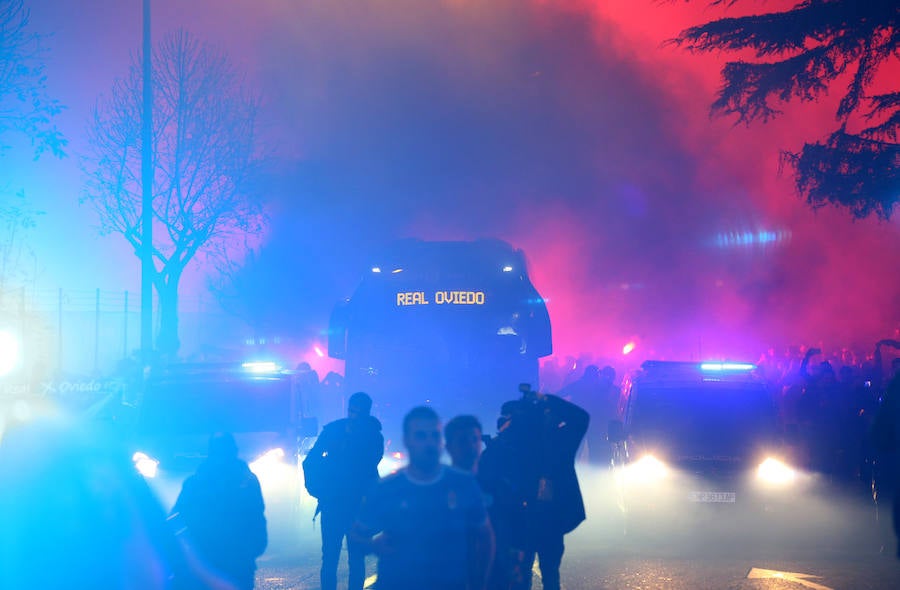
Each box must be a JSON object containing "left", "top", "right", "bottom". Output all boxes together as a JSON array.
[{"left": 328, "top": 240, "right": 552, "bottom": 431}]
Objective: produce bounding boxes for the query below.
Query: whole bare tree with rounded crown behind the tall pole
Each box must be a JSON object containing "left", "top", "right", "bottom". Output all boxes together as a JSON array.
[{"left": 82, "top": 31, "right": 265, "bottom": 355}]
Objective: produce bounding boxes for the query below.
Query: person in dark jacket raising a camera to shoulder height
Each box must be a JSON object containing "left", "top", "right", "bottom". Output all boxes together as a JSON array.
[{"left": 479, "top": 388, "right": 590, "bottom": 590}]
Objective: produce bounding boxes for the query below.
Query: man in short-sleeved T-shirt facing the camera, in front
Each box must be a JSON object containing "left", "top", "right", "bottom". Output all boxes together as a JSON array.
[{"left": 353, "top": 406, "right": 491, "bottom": 590}]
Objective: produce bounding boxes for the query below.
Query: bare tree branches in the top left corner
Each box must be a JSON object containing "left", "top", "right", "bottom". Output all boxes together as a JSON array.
[{"left": 0, "top": 0, "right": 66, "bottom": 156}]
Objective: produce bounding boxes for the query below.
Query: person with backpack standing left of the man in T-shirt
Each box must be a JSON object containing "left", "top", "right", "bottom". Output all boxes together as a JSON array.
[{"left": 303, "top": 392, "right": 384, "bottom": 590}]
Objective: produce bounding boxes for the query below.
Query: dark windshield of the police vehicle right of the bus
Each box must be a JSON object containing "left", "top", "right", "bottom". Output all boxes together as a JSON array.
[{"left": 630, "top": 381, "right": 777, "bottom": 458}]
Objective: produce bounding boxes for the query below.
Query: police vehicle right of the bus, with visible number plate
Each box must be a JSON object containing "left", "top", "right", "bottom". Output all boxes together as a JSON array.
[{"left": 609, "top": 361, "right": 801, "bottom": 528}]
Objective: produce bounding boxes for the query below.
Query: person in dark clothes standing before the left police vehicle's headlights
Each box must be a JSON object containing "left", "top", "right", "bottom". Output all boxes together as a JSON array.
[{"left": 170, "top": 432, "right": 268, "bottom": 590}]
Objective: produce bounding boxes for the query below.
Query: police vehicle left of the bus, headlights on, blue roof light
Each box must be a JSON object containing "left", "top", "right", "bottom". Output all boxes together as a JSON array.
[{"left": 130, "top": 361, "right": 316, "bottom": 489}]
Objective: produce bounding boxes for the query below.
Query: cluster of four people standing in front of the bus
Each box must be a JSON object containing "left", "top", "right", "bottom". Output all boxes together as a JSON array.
[{"left": 303, "top": 386, "right": 589, "bottom": 590}]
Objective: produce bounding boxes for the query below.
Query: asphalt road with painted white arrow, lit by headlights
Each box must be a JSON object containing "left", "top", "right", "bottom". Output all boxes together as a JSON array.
[{"left": 251, "top": 473, "right": 900, "bottom": 590}]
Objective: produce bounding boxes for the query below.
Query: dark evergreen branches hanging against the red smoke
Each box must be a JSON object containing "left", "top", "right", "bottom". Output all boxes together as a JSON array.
[{"left": 671, "top": 0, "right": 900, "bottom": 219}]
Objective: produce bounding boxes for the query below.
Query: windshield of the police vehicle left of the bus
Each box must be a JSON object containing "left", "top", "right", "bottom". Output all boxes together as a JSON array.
[{"left": 139, "top": 378, "right": 291, "bottom": 435}]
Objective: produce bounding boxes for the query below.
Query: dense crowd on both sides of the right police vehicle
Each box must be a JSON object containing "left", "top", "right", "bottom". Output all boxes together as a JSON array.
[{"left": 542, "top": 339, "right": 900, "bottom": 486}]
